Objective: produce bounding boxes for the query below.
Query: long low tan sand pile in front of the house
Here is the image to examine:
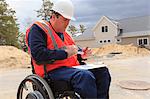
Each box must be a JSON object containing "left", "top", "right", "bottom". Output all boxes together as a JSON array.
[{"left": 92, "top": 44, "right": 150, "bottom": 56}]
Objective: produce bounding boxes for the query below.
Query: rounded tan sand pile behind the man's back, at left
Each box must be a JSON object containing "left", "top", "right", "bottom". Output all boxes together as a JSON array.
[{"left": 0, "top": 46, "right": 30, "bottom": 68}]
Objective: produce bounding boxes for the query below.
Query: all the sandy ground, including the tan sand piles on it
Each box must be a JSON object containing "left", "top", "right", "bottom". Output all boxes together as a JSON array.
[{"left": 0, "top": 45, "right": 150, "bottom": 99}]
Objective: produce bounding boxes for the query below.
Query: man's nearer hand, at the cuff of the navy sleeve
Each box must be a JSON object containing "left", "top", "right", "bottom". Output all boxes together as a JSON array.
[{"left": 65, "top": 45, "right": 78, "bottom": 57}]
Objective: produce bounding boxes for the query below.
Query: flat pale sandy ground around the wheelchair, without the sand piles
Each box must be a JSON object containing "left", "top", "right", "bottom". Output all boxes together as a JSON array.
[{"left": 0, "top": 56, "right": 150, "bottom": 99}]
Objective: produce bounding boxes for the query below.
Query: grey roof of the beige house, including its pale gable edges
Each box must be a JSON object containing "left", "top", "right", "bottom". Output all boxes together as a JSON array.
[{"left": 74, "top": 15, "right": 150, "bottom": 41}]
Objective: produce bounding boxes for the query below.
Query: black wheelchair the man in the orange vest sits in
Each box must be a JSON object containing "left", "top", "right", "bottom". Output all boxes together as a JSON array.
[{"left": 17, "top": 64, "right": 81, "bottom": 99}]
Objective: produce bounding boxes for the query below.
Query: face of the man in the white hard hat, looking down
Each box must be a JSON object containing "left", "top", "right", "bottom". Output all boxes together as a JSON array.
[{"left": 55, "top": 15, "right": 70, "bottom": 32}]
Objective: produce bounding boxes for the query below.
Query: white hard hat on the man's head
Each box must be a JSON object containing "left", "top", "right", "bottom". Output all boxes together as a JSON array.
[{"left": 52, "top": 0, "right": 75, "bottom": 20}]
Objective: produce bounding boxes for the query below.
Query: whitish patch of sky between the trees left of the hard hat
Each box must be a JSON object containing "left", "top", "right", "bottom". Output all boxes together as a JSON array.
[{"left": 6, "top": 0, "right": 42, "bottom": 32}]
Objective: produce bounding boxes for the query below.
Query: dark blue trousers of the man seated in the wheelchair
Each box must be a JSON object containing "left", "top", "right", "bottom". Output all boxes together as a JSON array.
[{"left": 49, "top": 67, "right": 111, "bottom": 99}]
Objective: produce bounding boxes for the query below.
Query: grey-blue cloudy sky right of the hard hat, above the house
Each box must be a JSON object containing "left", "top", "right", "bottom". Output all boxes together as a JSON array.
[{"left": 73, "top": 0, "right": 150, "bottom": 27}]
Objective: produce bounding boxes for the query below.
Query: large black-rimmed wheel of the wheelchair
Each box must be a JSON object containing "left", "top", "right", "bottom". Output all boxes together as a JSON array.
[{"left": 17, "top": 74, "right": 54, "bottom": 99}]
